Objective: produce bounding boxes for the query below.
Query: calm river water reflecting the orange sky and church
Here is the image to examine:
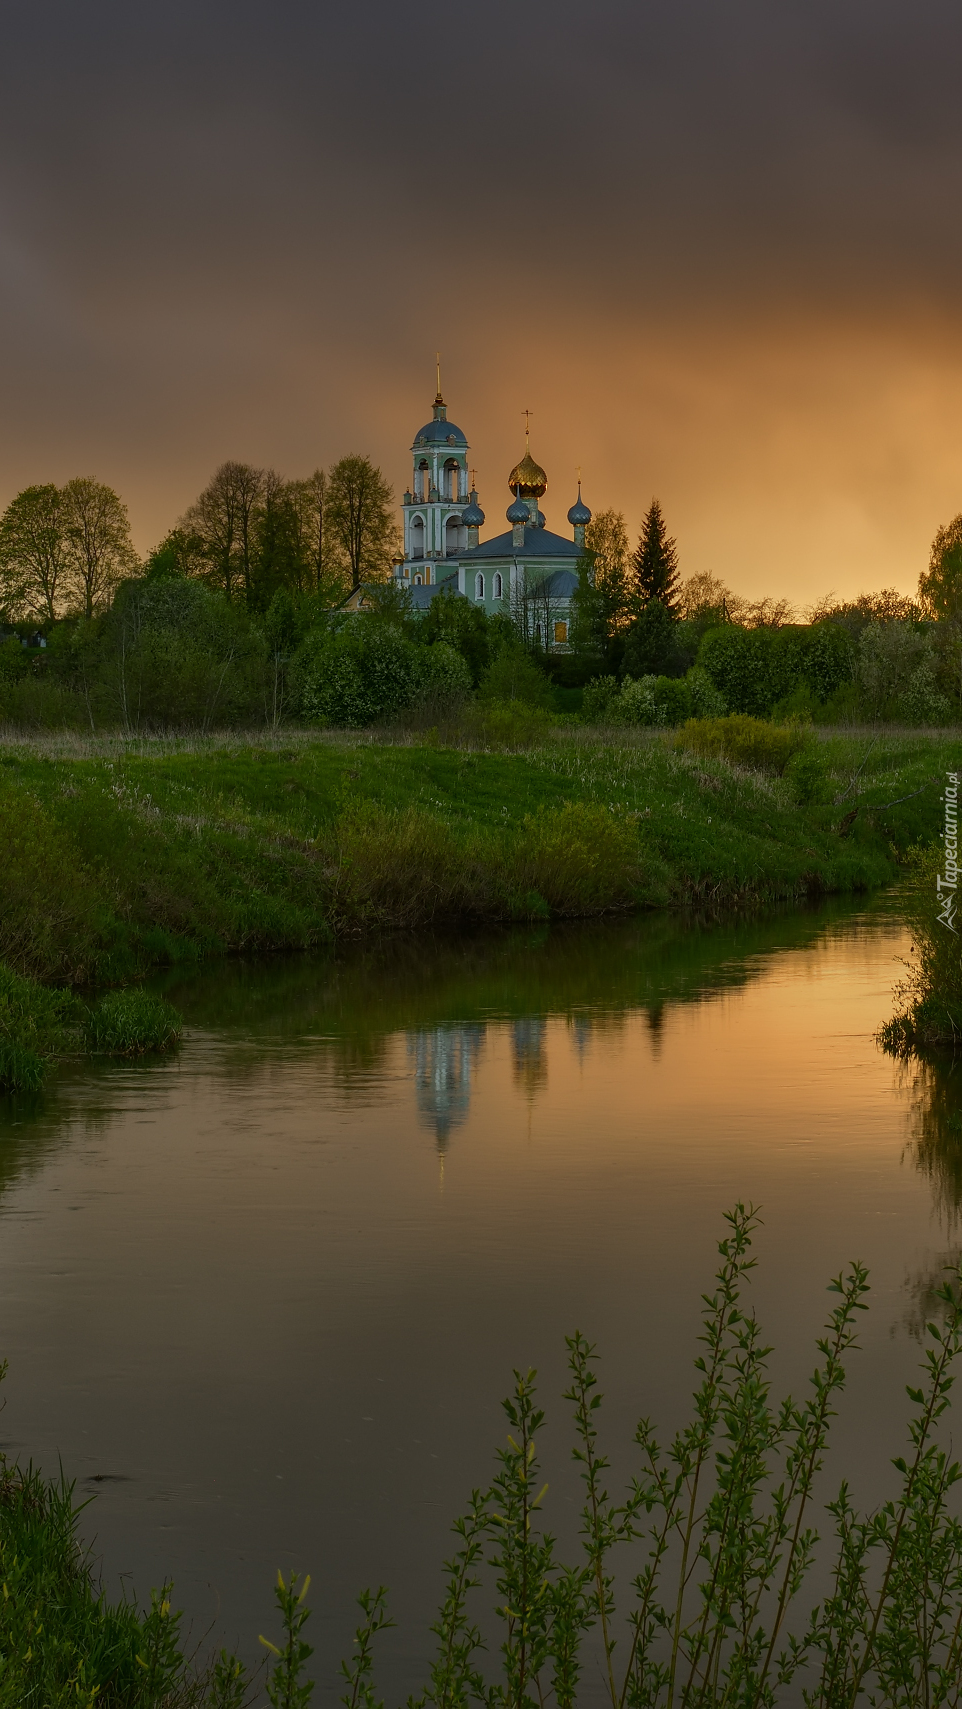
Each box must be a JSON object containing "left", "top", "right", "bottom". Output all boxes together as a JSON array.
[{"left": 0, "top": 902, "right": 962, "bottom": 1700}]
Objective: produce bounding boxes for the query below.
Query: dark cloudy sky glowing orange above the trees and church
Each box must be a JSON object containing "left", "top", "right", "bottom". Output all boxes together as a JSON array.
[{"left": 0, "top": 0, "right": 962, "bottom": 607}]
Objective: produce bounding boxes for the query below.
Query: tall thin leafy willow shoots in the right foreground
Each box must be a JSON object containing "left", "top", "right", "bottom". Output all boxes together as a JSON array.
[{"left": 322, "top": 1205, "right": 962, "bottom": 1709}]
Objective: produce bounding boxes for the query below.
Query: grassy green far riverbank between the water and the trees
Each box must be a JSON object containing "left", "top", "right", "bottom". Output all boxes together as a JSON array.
[{"left": 0, "top": 731, "right": 962, "bottom": 984}]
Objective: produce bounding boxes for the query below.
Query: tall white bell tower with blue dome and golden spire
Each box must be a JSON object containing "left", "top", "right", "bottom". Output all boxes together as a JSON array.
[{"left": 400, "top": 364, "right": 468, "bottom": 584}]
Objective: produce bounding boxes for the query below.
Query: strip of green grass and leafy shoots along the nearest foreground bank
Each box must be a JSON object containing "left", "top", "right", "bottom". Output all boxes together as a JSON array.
[{"left": 9, "top": 1205, "right": 962, "bottom": 1709}]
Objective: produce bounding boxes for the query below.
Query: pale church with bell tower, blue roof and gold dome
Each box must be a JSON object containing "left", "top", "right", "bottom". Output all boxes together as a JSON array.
[{"left": 393, "top": 386, "right": 591, "bottom": 649}]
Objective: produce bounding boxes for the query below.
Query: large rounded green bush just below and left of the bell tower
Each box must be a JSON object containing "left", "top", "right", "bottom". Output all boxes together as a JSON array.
[{"left": 290, "top": 617, "right": 417, "bottom": 728}]
